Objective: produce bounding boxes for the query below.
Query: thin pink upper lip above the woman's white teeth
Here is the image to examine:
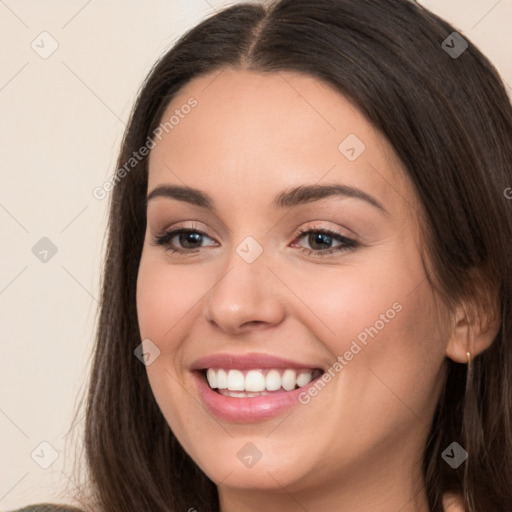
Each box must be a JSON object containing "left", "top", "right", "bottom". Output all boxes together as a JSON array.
[{"left": 190, "top": 353, "right": 322, "bottom": 370}]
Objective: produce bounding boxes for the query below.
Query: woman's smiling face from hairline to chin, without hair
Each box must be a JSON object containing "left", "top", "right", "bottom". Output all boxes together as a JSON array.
[{"left": 137, "top": 69, "right": 447, "bottom": 506}]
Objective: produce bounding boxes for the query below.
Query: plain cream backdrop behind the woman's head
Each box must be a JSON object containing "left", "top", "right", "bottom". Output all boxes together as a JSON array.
[{"left": 0, "top": 0, "right": 512, "bottom": 511}]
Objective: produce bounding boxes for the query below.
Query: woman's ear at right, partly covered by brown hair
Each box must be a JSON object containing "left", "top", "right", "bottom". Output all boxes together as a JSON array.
[{"left": 446, "top": 273, "right": 501, "bottom": 363}]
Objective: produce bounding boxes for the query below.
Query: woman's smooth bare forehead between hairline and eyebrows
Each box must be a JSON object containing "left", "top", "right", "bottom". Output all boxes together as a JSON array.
[{"left": 148, "top": 68, "right": 414, "bottom": 214}]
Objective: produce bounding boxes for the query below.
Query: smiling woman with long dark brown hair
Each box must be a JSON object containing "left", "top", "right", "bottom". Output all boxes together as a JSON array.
[{"left": 11, "top": 0, "right": 512, "bottom": 512}]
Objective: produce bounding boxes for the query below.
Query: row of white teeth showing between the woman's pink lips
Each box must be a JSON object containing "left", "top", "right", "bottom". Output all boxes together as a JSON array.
[{"left": 202, "top": 368, "right": 324, "bottom": 398}]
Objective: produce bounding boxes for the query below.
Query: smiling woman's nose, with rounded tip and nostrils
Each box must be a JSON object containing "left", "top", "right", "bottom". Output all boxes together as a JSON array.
[{"left": 204, "top": 242, "right": 286, "bottom": 334}]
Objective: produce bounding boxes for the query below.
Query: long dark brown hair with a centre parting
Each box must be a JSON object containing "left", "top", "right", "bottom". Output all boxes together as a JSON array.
[{"left": 64, "top": 0, "right": 512, "bottom": 512}]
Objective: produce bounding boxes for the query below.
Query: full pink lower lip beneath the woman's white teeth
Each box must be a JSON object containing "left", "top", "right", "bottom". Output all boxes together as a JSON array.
[{"left": 192, "top": 371, "right": 321, "bottom": 423}]
